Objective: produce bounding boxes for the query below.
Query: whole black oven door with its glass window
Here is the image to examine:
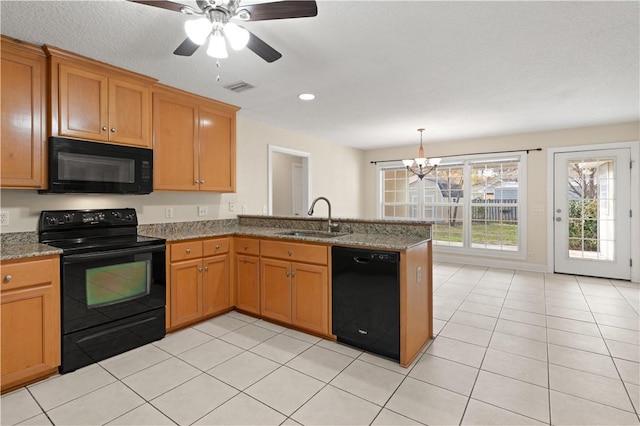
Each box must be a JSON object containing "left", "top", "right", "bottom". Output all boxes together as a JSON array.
[{"left": 62, "top": 246, "right": 166, "bottom": 333}]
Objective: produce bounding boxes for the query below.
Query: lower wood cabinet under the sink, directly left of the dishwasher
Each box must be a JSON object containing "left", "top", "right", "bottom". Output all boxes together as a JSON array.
[{"left": 260, "top": 241, "right": 329, "bottom": 335}]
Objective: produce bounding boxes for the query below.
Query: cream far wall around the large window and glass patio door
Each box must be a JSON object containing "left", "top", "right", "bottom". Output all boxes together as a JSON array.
[{"left": 362, "top": 122, "right": 640, "bottom": 269}]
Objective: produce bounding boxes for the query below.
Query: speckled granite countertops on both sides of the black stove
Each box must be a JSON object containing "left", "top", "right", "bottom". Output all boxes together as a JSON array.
[{"left": 0, "top": 217, "right": 430, "bottom": 260}]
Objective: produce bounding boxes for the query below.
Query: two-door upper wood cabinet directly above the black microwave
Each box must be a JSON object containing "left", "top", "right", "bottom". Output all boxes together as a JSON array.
[{"left": 45, "top": 46, "right": 155, "bottom": 148}]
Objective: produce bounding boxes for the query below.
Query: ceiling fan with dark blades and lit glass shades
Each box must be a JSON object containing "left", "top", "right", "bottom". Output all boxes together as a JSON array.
[{"left": 128, "top": 0, "right": 318, "bottom": 62}]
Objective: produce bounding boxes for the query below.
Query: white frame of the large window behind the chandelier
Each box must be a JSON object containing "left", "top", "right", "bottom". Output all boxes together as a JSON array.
[{"left": 376, "top": 151, "right": 528, "bottom": 260}]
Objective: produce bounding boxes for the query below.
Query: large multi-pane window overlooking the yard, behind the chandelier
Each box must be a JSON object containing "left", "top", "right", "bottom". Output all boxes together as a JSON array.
[{"left": 379, "top": 154, "right": 526, "bottom": 255}]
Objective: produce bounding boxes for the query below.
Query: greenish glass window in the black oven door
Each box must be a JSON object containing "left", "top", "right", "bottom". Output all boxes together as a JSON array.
[{"left": 85, "top": 260, "right": 151, "bottom": 308}]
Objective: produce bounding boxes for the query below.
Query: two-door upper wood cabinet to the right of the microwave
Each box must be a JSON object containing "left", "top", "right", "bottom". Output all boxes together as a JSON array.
[{"left": 153, "top": 85, "right": 238, "bottom": 192}]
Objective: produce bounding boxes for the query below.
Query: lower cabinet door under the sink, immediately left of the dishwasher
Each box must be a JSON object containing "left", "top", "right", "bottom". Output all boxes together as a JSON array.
[{"left": 291, "top": 263, "right": 329, "bottom": 334}]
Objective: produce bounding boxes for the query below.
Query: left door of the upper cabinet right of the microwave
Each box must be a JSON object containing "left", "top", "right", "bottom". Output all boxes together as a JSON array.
[{"left": 153, "top": 93, "right": 199, "bottom": 191}]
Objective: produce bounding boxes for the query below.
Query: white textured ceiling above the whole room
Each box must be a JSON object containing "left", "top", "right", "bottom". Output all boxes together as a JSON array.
[{"left": 0, "top": 0, "right": 640, "bottom": 149}]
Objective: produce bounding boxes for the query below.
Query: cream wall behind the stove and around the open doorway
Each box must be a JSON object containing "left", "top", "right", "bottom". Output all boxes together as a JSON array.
[{"left": 0, "top": 114, "right": 363, "bottom": 233}]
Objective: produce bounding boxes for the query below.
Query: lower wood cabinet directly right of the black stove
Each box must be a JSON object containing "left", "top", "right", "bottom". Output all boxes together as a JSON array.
[{"left": 168, "top": 238, "right": 231, "bottom": 328}]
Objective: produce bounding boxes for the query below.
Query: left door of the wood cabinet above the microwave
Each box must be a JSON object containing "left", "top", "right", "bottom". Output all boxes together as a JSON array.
[{"left": 58, "top": 63, "right": 109, "bottom": 141}]
